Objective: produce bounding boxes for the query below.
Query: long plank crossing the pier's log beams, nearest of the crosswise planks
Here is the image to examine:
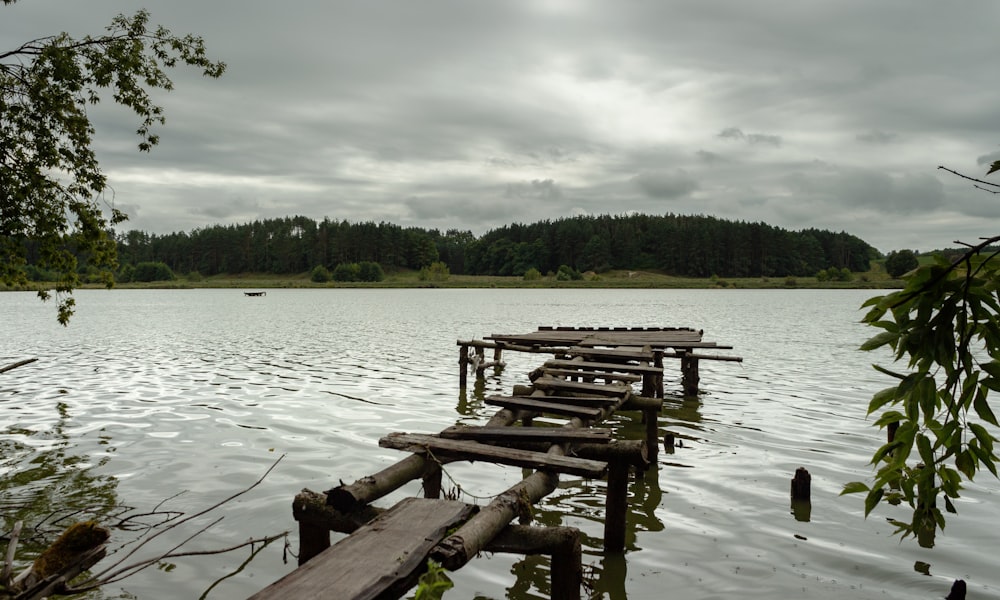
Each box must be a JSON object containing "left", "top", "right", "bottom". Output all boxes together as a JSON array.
[{"left": 378, "top": 433, "right": 608, "bottom": 478}]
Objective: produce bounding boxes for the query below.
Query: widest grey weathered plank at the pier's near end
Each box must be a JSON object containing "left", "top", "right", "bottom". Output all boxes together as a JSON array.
[{"left": 251, "top": 498, "right": 475, "bottom": 600}]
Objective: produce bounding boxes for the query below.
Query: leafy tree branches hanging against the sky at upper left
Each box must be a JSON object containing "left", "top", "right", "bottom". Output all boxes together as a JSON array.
[{"left": 0, "top": 0, "right": 226, "bottom": 325}]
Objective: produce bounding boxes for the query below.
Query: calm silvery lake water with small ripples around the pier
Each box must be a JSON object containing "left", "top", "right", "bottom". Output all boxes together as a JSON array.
[{"left": 0, "top": 289, "right": 1000, "bottom": 600}]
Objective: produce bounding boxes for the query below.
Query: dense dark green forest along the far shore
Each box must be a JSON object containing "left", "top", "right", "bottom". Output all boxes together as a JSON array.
[{"left": 105, "top": 214, "right": 878, "bottom": 277}]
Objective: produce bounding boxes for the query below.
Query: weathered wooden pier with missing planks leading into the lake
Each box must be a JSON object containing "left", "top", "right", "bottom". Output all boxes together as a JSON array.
[{"left": 253, "top": 328, "right": 741, "bottom": 600}]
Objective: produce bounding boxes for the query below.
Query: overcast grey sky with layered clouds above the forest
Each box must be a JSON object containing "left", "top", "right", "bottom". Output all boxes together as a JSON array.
[{"left": 0, "top": 0, "right": 1000, "bottom": 252}]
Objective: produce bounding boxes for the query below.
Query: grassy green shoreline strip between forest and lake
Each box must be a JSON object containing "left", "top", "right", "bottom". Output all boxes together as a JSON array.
[{"left": 52, "top": 271, "right": 903, "bottom": 290}]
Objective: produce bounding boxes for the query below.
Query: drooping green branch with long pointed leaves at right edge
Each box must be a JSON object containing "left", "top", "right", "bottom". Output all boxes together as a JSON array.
[{"left": 842, "top": 161, "right": 1000, "bottom": 545}]
